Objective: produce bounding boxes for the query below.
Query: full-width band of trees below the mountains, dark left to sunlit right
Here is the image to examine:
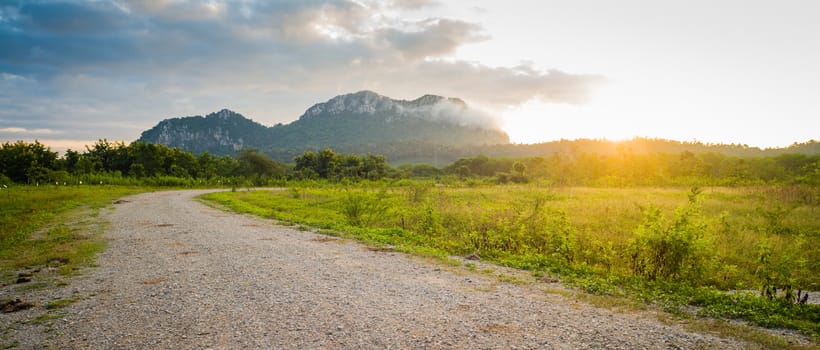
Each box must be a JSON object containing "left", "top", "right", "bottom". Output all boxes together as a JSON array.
[{"left": 0, "top": 140, "right": 820, "bottom": 187}]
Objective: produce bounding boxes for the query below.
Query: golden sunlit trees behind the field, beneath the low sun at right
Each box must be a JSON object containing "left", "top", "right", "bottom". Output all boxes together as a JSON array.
[{"left": 443, "top": 151, "right": 820, "bottom": 187}]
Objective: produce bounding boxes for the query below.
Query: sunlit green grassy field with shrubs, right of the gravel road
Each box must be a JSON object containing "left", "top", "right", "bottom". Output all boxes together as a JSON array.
[{"left": 204, "top": 180, "right": 820, "bottom": 336}]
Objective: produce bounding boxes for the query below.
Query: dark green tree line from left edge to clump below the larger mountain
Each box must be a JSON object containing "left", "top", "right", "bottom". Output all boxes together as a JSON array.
[{"left": 0, "top": 140, "right": 398, "bottom": 185}]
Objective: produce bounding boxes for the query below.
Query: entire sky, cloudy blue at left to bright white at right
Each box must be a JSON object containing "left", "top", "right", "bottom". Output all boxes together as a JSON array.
[{"left": 0, "top": 0, "right": 820, "bottom": 150}]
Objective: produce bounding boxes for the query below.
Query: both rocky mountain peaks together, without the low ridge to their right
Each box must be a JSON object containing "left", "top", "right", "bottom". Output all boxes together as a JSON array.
[{"left": 139, "top": 91, "right": 509, "bottom": 161}]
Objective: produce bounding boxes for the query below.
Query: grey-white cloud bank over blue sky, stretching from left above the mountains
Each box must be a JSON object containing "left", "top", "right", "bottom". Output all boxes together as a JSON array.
[{"left": 0, "top": 0, "right": 603, "bottom": 139}]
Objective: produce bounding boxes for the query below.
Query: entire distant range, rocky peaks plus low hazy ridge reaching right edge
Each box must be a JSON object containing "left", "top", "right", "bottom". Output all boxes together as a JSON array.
[{"left": 139, "top": 91, "right": 820, "bottom": 166}]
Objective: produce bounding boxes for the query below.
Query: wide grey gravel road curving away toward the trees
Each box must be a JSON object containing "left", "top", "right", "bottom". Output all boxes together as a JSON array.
[{"left": 0, "top": 191, "right": 756, "bottom": 349}]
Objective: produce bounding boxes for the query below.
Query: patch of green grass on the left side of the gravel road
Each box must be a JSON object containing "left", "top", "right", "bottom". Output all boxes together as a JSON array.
[{"left": 0, "top": 186, "right": 146, "bottom": 288}]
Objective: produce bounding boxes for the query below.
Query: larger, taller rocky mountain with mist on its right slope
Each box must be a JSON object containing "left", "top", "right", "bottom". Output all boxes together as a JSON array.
[{"left": 266, "top": 91, "right": 509, "bottom": 151}]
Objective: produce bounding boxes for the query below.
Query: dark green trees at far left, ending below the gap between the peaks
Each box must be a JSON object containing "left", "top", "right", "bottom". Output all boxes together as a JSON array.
[{"left": 0, "top": 140, "right": 294, "bottom": 187}]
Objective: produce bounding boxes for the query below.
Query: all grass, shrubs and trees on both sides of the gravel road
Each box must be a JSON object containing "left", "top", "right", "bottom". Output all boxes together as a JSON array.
[{"left": 0, "top": 140, "right": 820, "bottom": 341}]
